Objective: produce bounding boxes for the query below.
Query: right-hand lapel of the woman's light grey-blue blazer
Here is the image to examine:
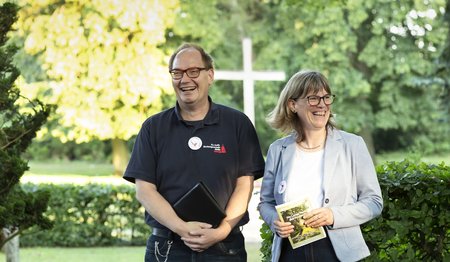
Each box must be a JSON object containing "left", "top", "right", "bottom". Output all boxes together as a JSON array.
[{"left": 323, "top": 130, "right": 342, "bottom": 192}]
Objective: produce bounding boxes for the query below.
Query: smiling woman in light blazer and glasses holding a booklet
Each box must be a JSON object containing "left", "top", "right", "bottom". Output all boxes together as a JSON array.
[{"left": 258, "top": 71, "right": 383, "bottom": 262}]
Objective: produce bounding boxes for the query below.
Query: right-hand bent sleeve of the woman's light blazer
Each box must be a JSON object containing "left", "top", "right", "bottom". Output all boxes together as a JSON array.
[{"left": 330, "top": 136, "right": 383, "bottom": 229}]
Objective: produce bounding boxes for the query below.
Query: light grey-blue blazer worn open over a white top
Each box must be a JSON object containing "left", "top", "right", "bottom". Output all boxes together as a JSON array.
[{"left": 258, "top": 129, "right": 383, "bottom": 262}]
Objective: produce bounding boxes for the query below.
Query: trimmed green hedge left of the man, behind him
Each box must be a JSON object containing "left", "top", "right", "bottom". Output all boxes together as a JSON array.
[{"left": 20, "top": 183, "right": 151, "bottom": 247}]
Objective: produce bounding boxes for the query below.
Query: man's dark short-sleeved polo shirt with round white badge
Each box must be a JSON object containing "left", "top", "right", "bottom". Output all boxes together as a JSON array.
[{"left": 124, "top": 99, "right": 264, "bottom": 227}]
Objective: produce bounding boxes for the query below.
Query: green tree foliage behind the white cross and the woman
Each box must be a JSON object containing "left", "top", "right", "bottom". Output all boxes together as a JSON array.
[{"left": 173, "top": 0, "right": 449, "bottom": 158}]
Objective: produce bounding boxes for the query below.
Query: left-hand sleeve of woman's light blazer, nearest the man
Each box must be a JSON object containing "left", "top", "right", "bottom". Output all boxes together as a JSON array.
[{"left": 258, "top": 144, "right": 280, "bottom": 232}]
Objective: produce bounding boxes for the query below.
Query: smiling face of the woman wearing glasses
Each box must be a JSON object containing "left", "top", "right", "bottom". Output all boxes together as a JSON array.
[{"left": 289, "top": 89, "right": 331, "bottom": 131}]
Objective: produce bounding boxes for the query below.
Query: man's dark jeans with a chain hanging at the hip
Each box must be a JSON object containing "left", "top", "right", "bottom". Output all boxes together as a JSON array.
[{"left": 145, "top": 232, "right": 247, "bottom": 262}]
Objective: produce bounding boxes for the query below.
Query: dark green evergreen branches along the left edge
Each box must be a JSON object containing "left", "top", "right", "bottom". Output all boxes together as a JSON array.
[{"left": 0, "top": 3, "right": 51, "bottom": 248}]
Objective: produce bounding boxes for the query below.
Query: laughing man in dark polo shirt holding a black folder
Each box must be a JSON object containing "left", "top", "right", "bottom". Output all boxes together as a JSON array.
[{"left": 124, "top": 44, "right": 264, "bottom": 262}]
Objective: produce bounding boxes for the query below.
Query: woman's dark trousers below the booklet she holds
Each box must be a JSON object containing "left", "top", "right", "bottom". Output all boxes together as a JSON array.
[{"left": 279, "top": 237, "right": 339, "bottom": 262}]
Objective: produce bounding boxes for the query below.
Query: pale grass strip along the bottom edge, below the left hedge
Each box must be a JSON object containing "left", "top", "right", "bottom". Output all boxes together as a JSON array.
[{"left": 0, "top": 243, "right": 261, "bottom": 262}]
